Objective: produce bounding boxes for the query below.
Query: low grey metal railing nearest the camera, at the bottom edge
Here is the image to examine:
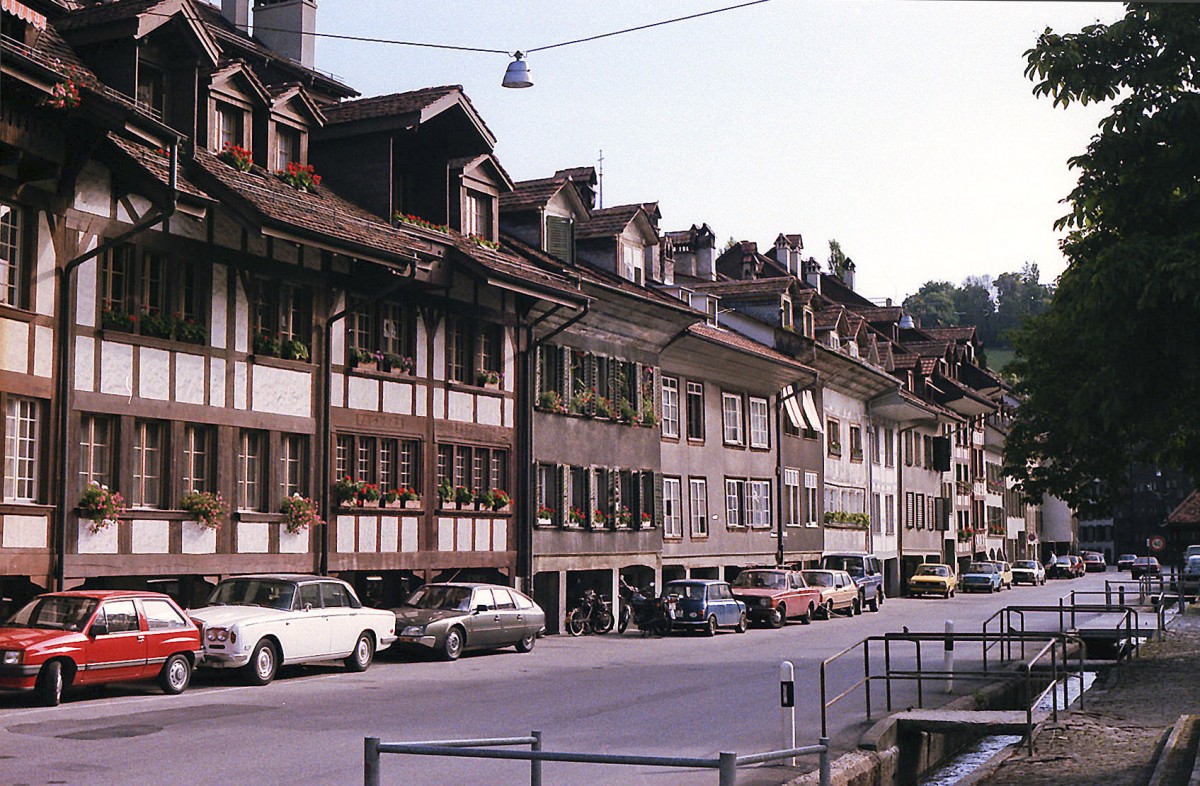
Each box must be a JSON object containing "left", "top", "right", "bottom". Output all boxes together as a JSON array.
[{"left": 362, "top": 731, "right": 832, "bottom": 786}]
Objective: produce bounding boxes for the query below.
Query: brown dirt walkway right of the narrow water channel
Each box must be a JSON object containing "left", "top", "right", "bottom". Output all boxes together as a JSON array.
[{"left": 970, "top": 608, "right": 1200, "bottom": 786}]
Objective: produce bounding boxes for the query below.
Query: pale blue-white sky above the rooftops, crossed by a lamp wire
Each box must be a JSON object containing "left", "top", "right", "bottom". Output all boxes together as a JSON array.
[{"left": 304, "top": 0, "right": 1123, "bottom": 302}]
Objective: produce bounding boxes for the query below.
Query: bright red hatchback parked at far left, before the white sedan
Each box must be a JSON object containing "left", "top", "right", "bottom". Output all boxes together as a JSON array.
[{"left": 0, "top": 589, "right": 202, "bottom": 707}]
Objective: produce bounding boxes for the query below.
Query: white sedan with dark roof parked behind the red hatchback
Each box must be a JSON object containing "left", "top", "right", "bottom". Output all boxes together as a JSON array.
[{"left": 190, "top": 574, "right": 396, "bottom": 685}]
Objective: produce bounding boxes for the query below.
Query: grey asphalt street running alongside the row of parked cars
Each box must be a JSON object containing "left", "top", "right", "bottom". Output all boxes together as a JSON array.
[{"left": 0, "top": 569, "right": 1128, "bottom": 786}]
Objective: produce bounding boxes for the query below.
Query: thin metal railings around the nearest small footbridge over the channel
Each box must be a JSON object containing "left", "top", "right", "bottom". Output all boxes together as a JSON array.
[{"left": 821, "top": 631, "right": 1085, "bottom": 749}]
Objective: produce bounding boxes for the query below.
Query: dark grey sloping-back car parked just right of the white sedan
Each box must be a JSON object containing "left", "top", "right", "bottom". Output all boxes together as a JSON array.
[{"left": 394, "top": 582, "right": 546, "bottom": 660}]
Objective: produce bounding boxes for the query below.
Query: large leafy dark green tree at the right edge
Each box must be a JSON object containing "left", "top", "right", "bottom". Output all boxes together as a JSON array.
[{"left": 1004, "top": 4, "right": 1200, "bottom": 512}]
